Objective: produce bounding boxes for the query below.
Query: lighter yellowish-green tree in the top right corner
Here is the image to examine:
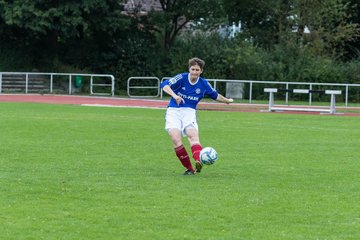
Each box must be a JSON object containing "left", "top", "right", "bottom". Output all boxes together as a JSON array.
[{"left": 291, "top": 0, "right": 360, "bottom": 58}]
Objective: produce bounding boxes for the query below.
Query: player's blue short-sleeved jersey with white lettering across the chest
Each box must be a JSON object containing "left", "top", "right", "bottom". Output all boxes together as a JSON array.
[{"left": 161, "top": 73, "right": 218, "bottom": 109}]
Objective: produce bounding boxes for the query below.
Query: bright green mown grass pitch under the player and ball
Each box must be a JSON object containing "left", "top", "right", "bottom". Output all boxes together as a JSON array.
[{"left": 0, "top": 103, "right": 360, "bottom": 240}]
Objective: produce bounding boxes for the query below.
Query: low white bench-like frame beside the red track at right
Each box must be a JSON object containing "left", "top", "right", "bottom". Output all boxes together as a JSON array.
[{"left": 264, "top": 88, "right": 341, "bottom": 114}]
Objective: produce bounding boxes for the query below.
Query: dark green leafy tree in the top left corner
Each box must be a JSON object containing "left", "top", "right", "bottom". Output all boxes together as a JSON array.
[{"left": 0, "top": 0, "right": 131, "bottom": 70}]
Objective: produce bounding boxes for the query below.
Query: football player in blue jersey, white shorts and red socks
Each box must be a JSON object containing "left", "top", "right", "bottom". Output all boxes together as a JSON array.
[{"left": 161, "top": 58, "right": 233, "bottom": 175}]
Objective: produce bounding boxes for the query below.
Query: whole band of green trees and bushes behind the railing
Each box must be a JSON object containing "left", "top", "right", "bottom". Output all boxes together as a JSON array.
[{"left": 0, "top": 0, "right": 360, "bottom": 86}]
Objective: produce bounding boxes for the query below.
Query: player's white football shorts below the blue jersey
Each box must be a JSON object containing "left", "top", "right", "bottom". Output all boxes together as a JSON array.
[{"left": 165, "top": 107, "right": 199, "bottom": 136}]
